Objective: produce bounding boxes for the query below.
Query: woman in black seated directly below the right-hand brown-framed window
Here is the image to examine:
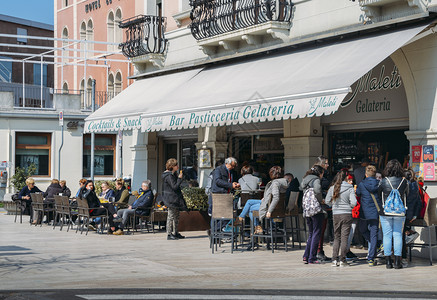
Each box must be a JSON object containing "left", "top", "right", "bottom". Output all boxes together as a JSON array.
[{"left": 80, "top": 180, "right": 118, "bottom": 234}]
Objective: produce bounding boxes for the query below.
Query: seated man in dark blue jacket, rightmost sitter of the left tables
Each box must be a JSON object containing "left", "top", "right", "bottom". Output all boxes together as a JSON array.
[{"left": 114, "top": 180, "right": 153, "bottom": 235}]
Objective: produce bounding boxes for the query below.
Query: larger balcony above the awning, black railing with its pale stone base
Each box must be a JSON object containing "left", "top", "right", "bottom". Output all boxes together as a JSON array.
[{"left": 190, "top": 0, "right": 293, "bottom": 54}]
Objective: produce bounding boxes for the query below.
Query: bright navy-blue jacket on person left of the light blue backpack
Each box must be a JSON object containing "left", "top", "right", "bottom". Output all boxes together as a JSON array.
[{"left": 356, "top": 177, "right": 382, "bottom": 220}]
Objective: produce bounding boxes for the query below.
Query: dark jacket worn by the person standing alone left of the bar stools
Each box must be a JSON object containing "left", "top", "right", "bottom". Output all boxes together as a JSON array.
[{"left": 161, "top": 171, "right": 186, "bottom": 209}]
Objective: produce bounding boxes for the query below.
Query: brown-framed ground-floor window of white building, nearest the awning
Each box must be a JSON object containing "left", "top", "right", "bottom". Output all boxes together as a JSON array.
[{"left": 83, "top": 134, "right": 116, "bottom": 177}]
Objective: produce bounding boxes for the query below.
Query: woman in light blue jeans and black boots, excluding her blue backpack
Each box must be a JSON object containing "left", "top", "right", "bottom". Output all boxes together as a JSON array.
[{"left": 378, "top": 159, "right": 408, "bottom": 269}]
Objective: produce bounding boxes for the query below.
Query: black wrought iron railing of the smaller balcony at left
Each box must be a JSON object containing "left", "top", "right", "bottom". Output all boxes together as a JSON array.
[{"left": 119, "top": 15, "right": 168, "bottom": 58}]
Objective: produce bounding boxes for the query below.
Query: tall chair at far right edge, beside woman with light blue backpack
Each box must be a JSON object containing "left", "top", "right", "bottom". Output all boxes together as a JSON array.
[{"left": 407, "top": 198, "right": 437, "bottom": 266}]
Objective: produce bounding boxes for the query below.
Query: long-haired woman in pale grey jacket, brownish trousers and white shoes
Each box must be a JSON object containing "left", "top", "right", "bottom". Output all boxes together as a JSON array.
[{"left": 325, "top": 170, "right": 357, "bottom": 267}]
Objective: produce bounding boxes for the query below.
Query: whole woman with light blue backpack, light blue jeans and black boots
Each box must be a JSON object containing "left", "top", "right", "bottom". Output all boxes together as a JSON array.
[{"left": 378, "top": 159, "right": 408, "bottom": 269}]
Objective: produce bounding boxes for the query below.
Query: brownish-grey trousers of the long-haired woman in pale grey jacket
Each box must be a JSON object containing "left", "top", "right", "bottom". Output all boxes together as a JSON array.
[{"left": 332, "top": 214, "right": 352, "bottom": 261}]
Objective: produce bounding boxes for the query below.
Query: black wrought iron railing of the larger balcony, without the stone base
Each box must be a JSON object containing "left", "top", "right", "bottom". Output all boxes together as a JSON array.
[{"left": 190, "top": 0, "right": 293, "bottom": 40}]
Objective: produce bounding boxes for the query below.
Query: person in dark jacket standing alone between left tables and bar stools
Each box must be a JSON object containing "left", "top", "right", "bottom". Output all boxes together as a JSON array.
[{"left": 161, "top": 158, "right": 185, "bottom": 240}]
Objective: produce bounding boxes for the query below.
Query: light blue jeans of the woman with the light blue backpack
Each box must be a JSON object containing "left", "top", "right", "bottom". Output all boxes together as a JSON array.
[{"left": 380, "top": 216, "right": 405, "bottom": 256}]
